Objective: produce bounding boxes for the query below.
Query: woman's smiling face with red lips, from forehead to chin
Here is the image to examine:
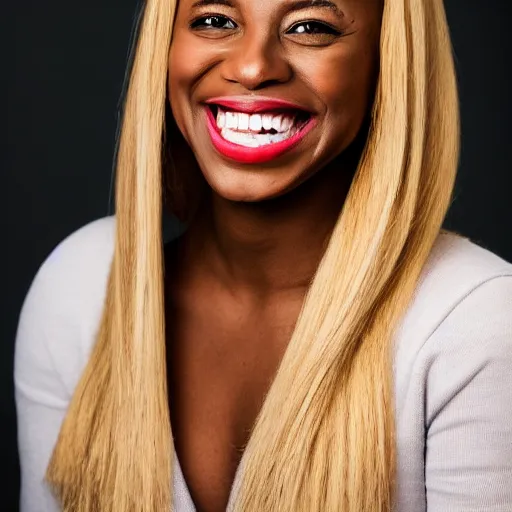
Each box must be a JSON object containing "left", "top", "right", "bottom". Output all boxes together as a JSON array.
[{"left": 168, "top": 0, "right": 382, "bottom": 201}]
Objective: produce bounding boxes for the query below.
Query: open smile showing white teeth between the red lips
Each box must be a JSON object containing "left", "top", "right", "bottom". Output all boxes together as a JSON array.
[{"left": 208, "top": 104, "right": 311, "bottom": 148}]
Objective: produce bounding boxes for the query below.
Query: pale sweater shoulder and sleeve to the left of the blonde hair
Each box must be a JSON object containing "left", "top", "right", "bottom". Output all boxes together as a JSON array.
[{"left": 13, "top": 217, "right": 115, "bottom": 512}]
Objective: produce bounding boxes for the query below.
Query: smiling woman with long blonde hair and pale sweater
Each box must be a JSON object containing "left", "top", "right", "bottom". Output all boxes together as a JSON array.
[{"left": 15, "top": 0, "right": 512, "bottom": 512}]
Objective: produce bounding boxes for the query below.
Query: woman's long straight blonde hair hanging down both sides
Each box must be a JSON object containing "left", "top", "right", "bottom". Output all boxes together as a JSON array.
[{"left": 46, "top": 0, "right": 459, "bottom": 512}]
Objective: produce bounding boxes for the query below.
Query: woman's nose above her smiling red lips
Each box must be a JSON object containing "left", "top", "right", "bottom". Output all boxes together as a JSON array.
[{"left": 223, "top": 33, "right": 293, "bottom": 91}]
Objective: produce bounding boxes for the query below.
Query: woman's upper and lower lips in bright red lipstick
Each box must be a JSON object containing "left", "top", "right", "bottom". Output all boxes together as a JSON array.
[{"left": 205, "top": 97, "right": 316, "bottom": 164}]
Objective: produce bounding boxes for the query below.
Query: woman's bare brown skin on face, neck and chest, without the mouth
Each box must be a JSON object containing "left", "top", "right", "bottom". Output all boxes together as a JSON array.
[{"left": 166, "top": 0, "right": 382, "bottom": 512}]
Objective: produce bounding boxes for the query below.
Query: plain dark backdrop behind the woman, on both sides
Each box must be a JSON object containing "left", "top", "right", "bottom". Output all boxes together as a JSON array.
[{"left": 4, "top": 0, "right": 512, "bottom": 511}]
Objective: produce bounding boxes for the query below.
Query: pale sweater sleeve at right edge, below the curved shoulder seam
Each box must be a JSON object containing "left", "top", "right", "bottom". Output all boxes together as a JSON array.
[{"left": 425, "top": 275, "right": 512, "bottom": 512}]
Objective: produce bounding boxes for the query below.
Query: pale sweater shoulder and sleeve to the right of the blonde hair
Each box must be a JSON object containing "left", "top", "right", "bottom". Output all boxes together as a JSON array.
[{"left": 394, "top": 233, "right": 512, "bottom": 511}]
